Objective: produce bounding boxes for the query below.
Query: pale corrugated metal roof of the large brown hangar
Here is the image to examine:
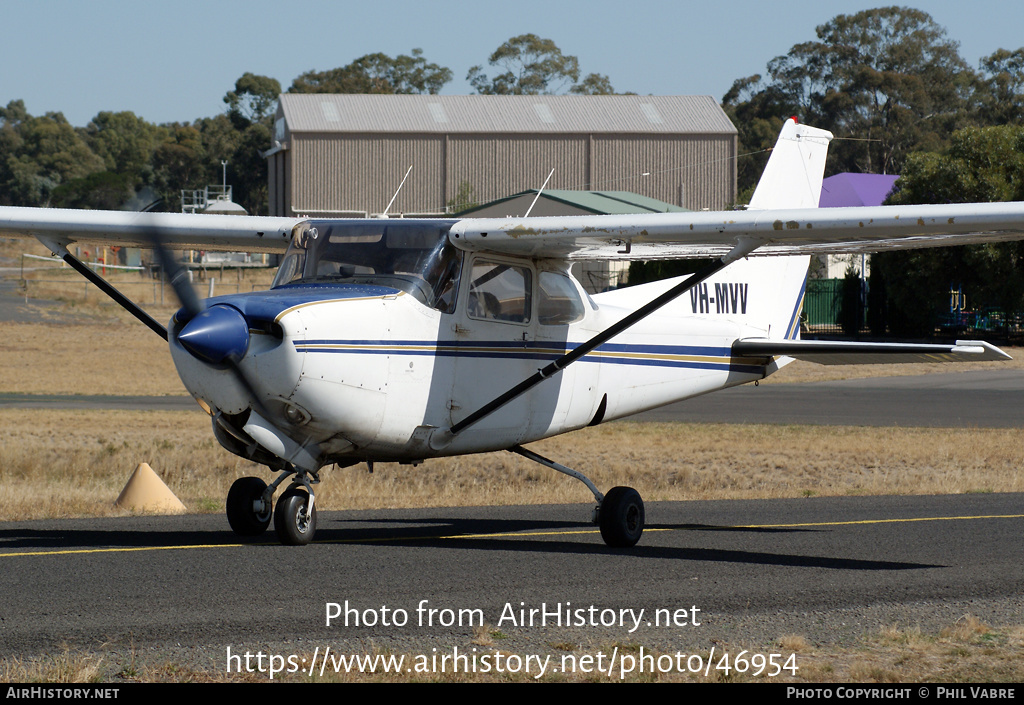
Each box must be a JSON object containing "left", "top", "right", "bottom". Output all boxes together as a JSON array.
[{"left": 278, "top": 93, "right": 736, "bottom": 134}]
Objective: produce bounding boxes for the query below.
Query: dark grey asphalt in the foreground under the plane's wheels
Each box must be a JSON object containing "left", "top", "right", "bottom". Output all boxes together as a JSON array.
[{"left": 0, "top": 494, "right": 1024, "bottom": 668}]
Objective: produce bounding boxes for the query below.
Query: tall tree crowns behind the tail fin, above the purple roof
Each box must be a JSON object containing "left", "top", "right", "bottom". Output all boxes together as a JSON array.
[{"left": 722, "top": 7, "right": 1024, "bottom": 198}]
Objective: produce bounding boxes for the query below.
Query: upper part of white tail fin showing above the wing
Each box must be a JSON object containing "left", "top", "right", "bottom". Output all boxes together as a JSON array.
[{"left": 750, "top": 118, "right": 833, "bottom": 209}]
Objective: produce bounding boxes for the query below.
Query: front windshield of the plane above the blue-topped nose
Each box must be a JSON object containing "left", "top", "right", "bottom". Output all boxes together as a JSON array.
[{"left": 273, "top": 219, "right": 462, "bottom": 313}]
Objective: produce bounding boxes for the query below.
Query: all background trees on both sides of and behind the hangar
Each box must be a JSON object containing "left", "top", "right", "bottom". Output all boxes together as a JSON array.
[{"left": 6, "top": 11, "right": 1024, "bottom": 332}]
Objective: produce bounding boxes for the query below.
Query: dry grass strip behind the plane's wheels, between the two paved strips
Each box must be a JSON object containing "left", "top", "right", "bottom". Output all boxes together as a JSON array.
[{"left": 0, "top": 408, "right": 1024, "bottom": 521}]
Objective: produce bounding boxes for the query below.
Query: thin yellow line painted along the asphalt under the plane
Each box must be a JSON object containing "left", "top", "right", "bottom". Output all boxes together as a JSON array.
[{"left": 0, "top": 514, "right": 1024, "bottom": 558}]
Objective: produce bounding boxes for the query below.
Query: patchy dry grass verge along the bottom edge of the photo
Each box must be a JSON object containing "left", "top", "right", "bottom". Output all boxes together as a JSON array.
[{"left": 0, "top": 615, "right": 1024, "bottom": 685}]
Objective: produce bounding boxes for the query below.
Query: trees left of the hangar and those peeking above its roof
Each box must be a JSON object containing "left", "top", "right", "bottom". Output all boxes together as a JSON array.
[{"left": 0, "top": 34, "right": 614, "bottom": 213}]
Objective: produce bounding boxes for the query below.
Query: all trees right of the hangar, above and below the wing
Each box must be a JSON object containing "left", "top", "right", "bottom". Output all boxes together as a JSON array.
[{"left": 688, "top": 6, "right": 1024, "bottom": 336}]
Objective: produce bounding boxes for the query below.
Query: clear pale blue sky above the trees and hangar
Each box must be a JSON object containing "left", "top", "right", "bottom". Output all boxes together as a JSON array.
[{"left": 0, "top": 0, "right": 1024, "bottom": 126}]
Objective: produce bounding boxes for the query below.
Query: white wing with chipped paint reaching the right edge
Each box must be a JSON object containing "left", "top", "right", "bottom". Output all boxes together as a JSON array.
[{"left": 452, "top": 202, "right": 1024, "bottom": 259}]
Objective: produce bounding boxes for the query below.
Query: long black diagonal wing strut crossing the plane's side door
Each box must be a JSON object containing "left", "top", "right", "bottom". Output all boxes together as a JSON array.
[{"left": 434, "top": 238, "right": 762, "bottom": 447}]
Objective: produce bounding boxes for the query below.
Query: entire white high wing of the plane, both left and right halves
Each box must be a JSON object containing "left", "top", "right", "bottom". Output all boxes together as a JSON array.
[{"left": 8, "top": 202, "right": 1024, "bottom": 260}]
